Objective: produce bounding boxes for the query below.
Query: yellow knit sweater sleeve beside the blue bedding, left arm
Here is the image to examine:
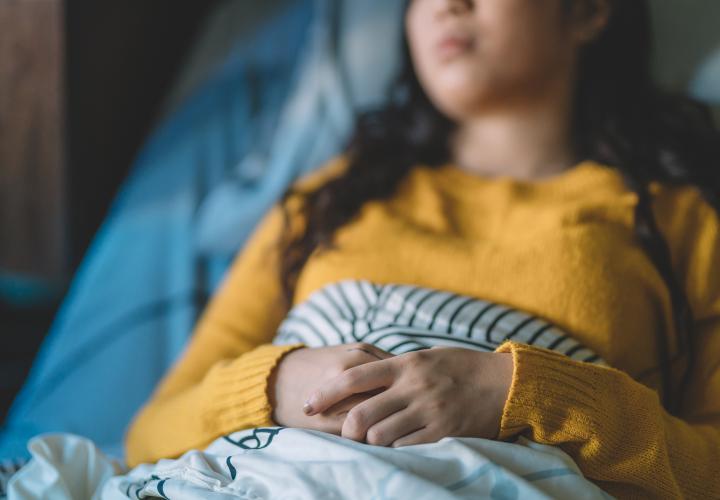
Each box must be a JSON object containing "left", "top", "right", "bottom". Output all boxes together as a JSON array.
[{"left": 125, "top": 200, "right": 303, "bottom": 467}]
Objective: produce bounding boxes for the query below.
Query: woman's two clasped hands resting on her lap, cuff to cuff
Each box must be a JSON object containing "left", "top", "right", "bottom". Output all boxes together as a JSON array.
[{"left": 268, "top": 343, "right": 514, "bottom": 447}]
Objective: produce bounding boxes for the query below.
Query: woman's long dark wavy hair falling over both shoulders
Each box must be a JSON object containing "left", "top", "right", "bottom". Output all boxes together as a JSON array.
[{"left": 281, "top": 0, "right": 720, "bottom": 414}]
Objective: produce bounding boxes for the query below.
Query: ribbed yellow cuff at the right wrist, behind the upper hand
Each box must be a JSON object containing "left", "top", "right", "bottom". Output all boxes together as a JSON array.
[{"left": 495, "top": 341, "right": 604, "bottom": 440}]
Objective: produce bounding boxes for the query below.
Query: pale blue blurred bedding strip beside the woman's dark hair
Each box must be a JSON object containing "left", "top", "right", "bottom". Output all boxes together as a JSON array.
[{"left": 191, "top": 0, "right": 403, "bottom": 256}]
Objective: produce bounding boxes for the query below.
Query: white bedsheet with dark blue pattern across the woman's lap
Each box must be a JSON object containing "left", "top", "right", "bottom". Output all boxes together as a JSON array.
[{"left": 9, "top": 427, "right": 611, "bottom": 500}]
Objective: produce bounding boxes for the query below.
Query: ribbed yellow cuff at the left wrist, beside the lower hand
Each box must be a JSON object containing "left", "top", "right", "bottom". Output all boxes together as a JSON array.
[{"left": 203, "top": 343, "right": 306, "bottom": 435}]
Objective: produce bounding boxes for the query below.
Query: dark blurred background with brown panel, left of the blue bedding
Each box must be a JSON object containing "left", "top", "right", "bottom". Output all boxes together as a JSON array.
[{"left": 0, "top": 0, "right": 226, "bottom": 422}]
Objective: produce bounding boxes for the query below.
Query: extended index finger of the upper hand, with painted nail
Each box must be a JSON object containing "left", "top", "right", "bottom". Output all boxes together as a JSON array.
[{"left": 303, "top": 360, "right": 394, "bottom": 415}]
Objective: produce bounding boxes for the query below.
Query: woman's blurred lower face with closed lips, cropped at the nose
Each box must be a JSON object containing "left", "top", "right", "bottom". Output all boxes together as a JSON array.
[{"left": 405, "top": 0, "right": 607, "bottom": 121}]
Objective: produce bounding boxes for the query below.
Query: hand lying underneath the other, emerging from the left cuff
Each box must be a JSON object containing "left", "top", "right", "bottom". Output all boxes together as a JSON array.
[{"left": 268, "top": 342, "right": 394, "bottom": 436}]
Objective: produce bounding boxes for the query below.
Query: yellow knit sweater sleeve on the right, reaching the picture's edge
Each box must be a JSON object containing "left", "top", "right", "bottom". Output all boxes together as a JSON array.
[{"left": 497, "top": 188, "right": 720, "bottom": 498}]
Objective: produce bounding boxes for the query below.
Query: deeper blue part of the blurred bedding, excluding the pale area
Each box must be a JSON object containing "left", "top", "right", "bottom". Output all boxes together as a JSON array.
[{"left": 0, "top": 0, "right": 313, "bottom": 458}]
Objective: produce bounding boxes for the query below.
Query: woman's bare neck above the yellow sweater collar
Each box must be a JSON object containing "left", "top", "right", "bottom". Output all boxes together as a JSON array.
[{"left": 451, "top": 84, "right": 576, "bottom": 180}]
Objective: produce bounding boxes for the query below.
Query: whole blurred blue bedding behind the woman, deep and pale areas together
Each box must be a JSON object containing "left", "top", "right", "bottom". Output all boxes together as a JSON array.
[{"left": 0, "top": 0, "right": 410, "bottom": 458}]
